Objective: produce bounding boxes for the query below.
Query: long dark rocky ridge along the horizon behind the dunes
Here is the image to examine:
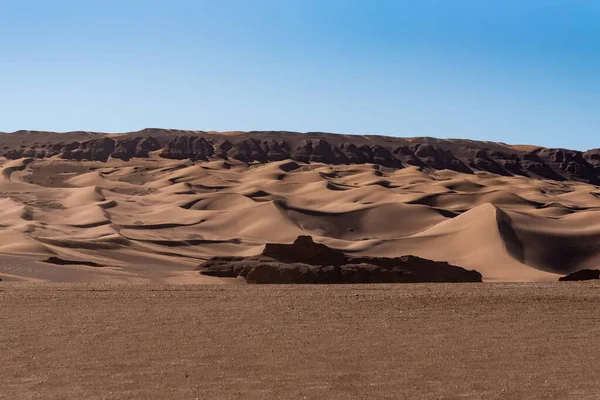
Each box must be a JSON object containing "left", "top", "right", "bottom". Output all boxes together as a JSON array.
[{"left": 0, "top": 129, "right": 600, "bottom": 184}]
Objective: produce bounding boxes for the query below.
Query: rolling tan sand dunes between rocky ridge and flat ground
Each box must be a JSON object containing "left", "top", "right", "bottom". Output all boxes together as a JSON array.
[{"left": 0, "top": 154, "right": 600, "bottom": 283}]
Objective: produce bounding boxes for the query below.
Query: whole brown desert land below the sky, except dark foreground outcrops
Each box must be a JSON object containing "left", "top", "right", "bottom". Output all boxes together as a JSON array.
[{"left": 0, "top": 130, "right": 600, "bottom": 399}]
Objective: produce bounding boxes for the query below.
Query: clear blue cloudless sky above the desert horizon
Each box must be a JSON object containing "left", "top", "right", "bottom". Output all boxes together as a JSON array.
[{"left": 0, "top": 0, "right": 600, "bottom": 149}]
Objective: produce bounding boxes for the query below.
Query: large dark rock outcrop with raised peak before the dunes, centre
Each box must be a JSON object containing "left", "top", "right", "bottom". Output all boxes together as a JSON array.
[{"left": 197, "top": 236, "right": 481, "bottom": 284}]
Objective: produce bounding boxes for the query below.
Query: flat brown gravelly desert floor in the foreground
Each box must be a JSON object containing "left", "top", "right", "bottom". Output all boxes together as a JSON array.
[{"left": 0, "top": 282, "right": 600, "bottom": 399}]
